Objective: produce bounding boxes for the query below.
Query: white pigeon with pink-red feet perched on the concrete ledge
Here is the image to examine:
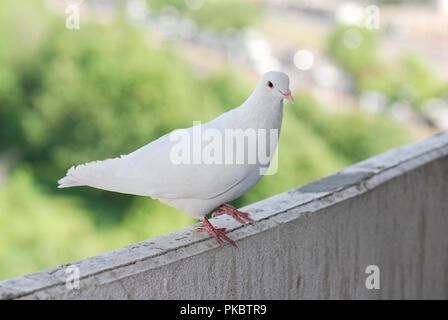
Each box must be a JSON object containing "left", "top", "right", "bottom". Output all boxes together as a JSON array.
[{"left": 58, "top": 71, "right": 294, "bottom": 246}]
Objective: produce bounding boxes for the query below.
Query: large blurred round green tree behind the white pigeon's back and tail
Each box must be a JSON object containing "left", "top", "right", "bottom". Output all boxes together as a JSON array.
[{"left": 20, "top": 25, "right": 216, "bottom": 180}]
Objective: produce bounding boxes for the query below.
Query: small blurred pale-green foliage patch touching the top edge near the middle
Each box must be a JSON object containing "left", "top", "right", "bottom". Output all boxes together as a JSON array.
[{"left": 148, "top": 0, "right": 262, "bottom": 32}]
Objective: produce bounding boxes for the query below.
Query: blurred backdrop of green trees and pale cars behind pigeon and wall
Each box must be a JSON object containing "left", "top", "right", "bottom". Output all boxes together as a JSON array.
[{"left": 0, "top": 0, "right": 448, "bottom": 279}]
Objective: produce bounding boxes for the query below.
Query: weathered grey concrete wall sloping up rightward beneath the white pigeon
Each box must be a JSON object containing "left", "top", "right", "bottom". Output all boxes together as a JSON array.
[{"left": 0, "top": 133, "right": 448, "bottom": 299}]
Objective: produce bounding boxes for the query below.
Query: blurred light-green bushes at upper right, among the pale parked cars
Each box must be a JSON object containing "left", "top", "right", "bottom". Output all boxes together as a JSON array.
[{"left": 328, "top": 26, "right": 448, "bottom": 110}]
